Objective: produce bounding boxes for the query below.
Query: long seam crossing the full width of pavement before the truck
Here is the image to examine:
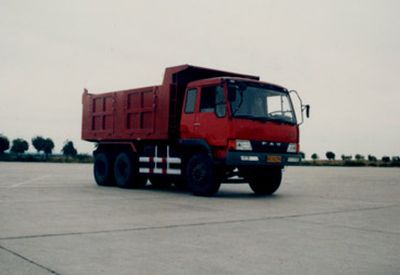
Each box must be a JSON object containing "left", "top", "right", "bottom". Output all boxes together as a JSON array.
[{"left": 0, "top": 204, "right": 399, "bottom": 241}]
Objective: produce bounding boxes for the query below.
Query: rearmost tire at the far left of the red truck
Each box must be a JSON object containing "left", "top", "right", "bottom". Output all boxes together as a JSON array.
[{"left": 93, "top": 152, "right": 115, "bottom": 186}]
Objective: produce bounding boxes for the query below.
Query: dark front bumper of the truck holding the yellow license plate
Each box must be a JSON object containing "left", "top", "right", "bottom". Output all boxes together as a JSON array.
[{"left": 226, "top": 151, "right": 301, "bottom": 166}]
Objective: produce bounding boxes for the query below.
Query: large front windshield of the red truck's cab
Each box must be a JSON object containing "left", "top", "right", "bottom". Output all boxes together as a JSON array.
[{"left": 228, "top": 81, "right": 296, "bottom": 124}]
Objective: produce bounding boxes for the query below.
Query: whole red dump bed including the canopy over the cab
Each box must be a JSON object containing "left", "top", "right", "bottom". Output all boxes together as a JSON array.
[{"left": 82, "top": 65, "right": 259, "bottom": 141}]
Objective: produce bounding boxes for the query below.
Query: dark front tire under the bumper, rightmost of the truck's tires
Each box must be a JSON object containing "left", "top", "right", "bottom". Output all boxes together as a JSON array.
[{"left": 248, "top": 168, "right": 282, "bottom": 196}]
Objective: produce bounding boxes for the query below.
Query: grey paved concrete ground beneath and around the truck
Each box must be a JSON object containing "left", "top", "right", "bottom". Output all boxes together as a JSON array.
[{"left": 0, "top": 163, "right": 400, "bottom": 274}]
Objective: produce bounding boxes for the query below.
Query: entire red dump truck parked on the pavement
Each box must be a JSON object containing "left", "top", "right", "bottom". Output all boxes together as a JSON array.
[{"left": 82, "top": 65, "right": 309, "bottom": 196}]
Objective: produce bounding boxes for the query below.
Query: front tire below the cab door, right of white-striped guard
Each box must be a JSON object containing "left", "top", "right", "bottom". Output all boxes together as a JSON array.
[{"left": 186, "top": 154, "right": 221, "bottom": 196}]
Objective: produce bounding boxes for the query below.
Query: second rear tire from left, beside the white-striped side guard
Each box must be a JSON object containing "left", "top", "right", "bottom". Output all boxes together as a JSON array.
[{"left": 114, "top": 152, "right": 147, "bottom": 188}]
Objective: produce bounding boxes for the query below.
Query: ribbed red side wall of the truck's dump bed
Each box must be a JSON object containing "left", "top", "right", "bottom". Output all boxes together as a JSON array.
[{"left": 82, "top": 86, "right": 168, "bottom": 141}]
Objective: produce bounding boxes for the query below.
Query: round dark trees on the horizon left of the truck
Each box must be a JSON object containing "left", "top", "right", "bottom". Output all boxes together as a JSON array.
[{"left": 0, "top": 134, "right": 78, "bottom": 157}]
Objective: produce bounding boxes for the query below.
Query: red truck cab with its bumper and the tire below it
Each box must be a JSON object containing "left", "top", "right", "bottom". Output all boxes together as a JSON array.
[{"left": 180, "top": 77, "right": 301, "bottom": 194}]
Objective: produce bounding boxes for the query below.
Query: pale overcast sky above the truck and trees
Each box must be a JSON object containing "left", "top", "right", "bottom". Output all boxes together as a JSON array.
[{"left": 0, "top": 0, "right": 400, "bottom": 158}]
